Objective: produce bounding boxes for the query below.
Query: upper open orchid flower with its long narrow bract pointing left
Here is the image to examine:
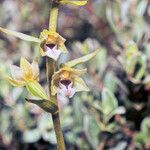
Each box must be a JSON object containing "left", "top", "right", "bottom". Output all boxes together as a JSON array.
[{"left": 0, "top": 27, "right": 67, "bottom": 60}]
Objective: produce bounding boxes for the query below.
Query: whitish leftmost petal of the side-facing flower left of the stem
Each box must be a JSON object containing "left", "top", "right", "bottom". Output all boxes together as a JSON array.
[{"left": 10, "top": 65, "right": 23, "bottom": 80}]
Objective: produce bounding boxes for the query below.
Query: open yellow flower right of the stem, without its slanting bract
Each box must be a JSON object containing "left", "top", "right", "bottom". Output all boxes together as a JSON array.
[{"left": 51, "top": 66, "right": 89, "bottom": 98}]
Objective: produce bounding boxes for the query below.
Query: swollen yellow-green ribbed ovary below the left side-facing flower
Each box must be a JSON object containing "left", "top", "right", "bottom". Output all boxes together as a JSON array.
[{"left": 26, "top": 81, "right": 48, "bottom": 99}]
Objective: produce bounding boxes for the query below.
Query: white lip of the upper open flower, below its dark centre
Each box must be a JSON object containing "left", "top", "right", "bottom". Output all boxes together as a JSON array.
[{"left": 45, "top": 46, "right": 61, "bottom": 60}]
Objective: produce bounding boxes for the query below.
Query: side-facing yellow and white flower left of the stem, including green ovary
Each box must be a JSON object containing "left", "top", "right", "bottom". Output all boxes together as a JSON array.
[{"left": 6, "top": 58, "right": 48, "bottom": 99}]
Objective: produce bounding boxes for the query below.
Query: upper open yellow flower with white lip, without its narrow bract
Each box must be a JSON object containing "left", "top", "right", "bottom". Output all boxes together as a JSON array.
[{"left": 40, "top": 29, "right": 67, "bottom": 60}]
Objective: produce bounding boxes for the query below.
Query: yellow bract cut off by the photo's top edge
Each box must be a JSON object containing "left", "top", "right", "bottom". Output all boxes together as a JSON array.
[{"left": 59, "top": 0, "right": 87, "bottom": 6}]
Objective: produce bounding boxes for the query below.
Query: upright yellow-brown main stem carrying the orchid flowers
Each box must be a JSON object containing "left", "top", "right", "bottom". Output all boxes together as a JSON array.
[{"left": 46, "top": 3, "right": 65, "bottom": 150}]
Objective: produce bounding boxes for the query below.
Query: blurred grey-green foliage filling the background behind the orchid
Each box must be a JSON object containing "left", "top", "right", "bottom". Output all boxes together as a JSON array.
[{"left": 0, "top": 0, "right": 150, "bottom": 150}]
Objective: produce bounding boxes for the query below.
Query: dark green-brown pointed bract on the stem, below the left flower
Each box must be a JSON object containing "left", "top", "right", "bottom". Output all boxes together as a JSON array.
[{"left": 25, "top": 98, "right": 58, "bottom": 114}]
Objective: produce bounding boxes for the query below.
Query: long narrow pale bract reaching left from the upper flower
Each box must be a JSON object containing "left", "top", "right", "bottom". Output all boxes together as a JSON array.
[{"left": 0, "top": 27, "right": 40, "bottom": 43}]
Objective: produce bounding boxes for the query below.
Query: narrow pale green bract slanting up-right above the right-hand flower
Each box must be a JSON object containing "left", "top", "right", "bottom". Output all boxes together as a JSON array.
[{"left": 64, "top": 49, "right": 99, "bottom": 67}]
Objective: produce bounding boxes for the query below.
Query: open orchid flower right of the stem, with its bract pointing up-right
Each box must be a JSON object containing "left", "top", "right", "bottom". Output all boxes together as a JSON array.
[{"left": 51, "top": 50, "right": 98, "bottom": 98}]
